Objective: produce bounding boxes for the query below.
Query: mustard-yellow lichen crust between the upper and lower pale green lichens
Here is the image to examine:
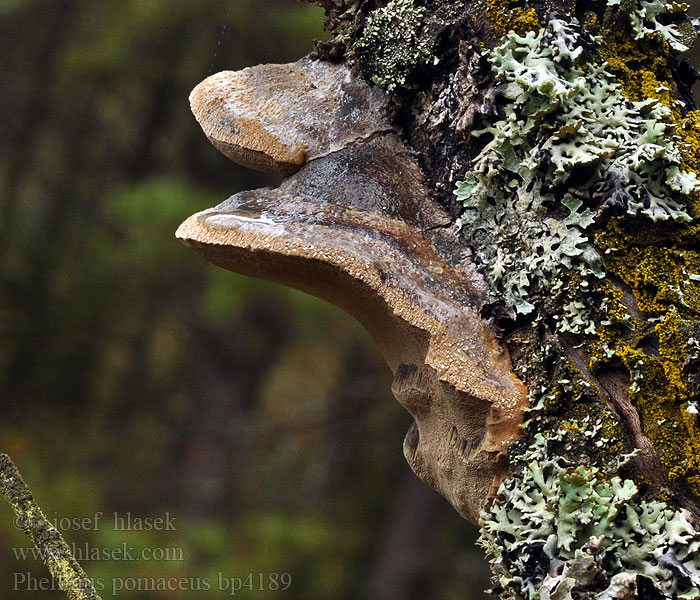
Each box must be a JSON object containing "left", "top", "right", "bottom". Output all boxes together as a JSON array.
[{"left": 590, "top": 219, "right": 700, "bottom": 496}]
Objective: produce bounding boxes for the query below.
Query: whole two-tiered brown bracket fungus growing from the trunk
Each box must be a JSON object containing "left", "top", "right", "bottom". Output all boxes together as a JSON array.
[{"left": 177, "top": 58, "right": 527, "bottom": 522}]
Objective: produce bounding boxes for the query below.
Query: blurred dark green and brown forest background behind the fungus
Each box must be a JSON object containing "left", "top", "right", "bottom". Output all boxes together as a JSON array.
[{"left": 0, "top": 0, "right": 699, "bottom": 600}]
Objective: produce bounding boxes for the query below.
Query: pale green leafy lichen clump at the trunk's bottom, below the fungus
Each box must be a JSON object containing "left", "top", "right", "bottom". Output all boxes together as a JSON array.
[{"left": 480, "top": 432, "right": 700, "bottom": 600}]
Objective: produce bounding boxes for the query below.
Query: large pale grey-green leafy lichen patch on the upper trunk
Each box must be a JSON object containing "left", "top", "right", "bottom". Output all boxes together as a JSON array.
[{"left": 455, "top": 19, "right": 700, "bottom": 322}]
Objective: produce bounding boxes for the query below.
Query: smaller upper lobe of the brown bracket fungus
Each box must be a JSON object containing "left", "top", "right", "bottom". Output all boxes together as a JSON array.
[{"left": 190, "top": 58, "right": 393, "bottom": 175}]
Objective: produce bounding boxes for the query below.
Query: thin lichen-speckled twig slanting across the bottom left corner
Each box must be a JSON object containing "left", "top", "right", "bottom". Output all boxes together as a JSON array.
[{"left": 0, "top": 454, "right": 100, "bottom": 600}]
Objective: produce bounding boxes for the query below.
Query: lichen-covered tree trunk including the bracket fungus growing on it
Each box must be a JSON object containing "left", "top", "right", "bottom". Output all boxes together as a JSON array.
[{"left": 178, "top": 0, "right": 700, "bottom": 600}]
